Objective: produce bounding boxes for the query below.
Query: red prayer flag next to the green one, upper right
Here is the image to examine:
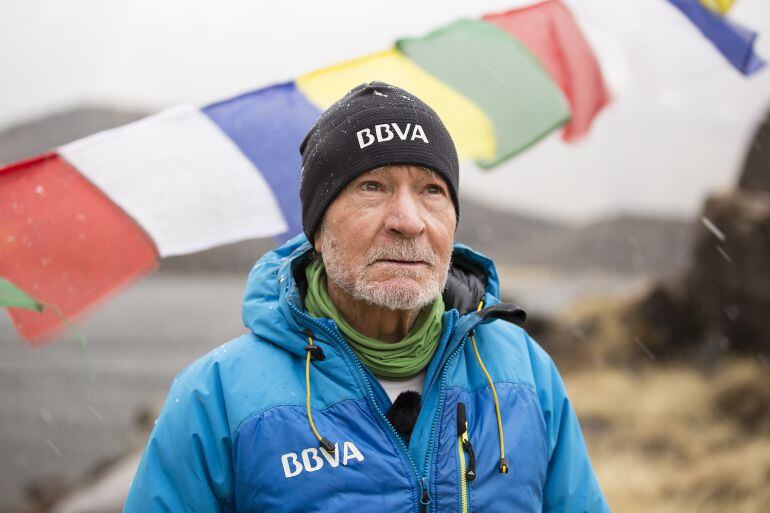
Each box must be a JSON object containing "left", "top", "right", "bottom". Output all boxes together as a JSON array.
[{"left": 483, "top": 0, "right": 610, "bottom": 141}]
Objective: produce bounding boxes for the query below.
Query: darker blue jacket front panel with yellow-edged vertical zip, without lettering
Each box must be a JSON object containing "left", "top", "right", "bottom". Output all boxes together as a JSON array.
[{"left": 434, "top": 383, "right": 548, "bottom": 513}]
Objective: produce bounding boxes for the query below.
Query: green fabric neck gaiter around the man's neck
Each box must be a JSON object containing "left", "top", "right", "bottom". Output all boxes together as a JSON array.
[{"left": 305, "top": 260, "right": 444, "bottom": 378}]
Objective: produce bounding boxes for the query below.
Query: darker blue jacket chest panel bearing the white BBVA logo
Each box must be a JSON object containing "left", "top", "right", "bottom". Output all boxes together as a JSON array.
[{"left": 233, "top": 399, "right": 416, "bottom": 513}]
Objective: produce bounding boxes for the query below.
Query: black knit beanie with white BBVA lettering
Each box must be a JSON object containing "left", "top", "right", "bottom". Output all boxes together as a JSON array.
[{"left": 299, "top": 82, "right": 460, "bottom": 243}]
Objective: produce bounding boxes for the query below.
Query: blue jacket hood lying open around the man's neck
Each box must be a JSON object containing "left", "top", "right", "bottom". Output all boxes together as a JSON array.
[{"left": 243, "top": 234, "right": 525, "bottom": 356}]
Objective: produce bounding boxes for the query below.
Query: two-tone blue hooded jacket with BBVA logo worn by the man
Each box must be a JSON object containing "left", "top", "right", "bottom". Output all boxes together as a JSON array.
[{"left": 124, "top": 236, "right": 609, "bottom": 513}]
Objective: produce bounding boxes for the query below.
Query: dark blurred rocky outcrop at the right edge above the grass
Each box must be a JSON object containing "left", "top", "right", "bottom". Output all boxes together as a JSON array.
[{"left": 627, "top": 112, "right": 770, "bottom": 361}]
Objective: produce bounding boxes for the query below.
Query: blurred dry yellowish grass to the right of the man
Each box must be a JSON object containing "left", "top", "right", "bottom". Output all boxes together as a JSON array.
[{"left": 565, "top": 359, "right": 770, "bottom": 513}]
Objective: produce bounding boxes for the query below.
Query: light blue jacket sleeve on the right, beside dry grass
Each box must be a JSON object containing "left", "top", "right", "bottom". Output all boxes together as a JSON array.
[{"left": 527, "top": 335, "right": 610, "bottom": 513}]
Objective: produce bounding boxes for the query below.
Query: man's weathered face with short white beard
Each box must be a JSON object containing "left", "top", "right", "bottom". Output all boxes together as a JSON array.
[{"left": 315, "top": 165, "right": 456, "bottom": 310}]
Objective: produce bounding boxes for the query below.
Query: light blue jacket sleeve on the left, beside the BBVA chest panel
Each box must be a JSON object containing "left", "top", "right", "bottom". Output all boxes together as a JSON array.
[{"left": 123, "top": 361, "right": 233, "bottom": 513}]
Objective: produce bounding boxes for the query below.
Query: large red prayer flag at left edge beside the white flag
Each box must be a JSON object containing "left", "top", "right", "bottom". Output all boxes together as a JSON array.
[{"left": 0, "top": 154, "right": 158, "bottom": 344}]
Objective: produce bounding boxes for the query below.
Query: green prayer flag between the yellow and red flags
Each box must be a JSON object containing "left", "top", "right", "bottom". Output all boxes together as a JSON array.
[{"left": 396, "top": 20, "right": 570, "bottom": 167}]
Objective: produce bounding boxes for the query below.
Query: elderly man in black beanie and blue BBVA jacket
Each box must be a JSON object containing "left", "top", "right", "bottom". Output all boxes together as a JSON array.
[{"left": 124, "top": 82, "right": 608, "bottom": 513}]
